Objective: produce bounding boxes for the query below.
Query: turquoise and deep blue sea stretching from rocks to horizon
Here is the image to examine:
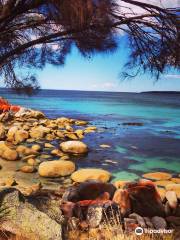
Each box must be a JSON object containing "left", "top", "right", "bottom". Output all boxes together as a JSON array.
[{"left": 0, "top": 89, "right": 180, "bottom": 179}]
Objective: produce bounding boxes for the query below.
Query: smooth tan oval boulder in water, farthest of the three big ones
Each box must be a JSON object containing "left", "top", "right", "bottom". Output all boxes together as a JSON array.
[{"left": 60, "top": 141, "right": 88, "bottom": 154}]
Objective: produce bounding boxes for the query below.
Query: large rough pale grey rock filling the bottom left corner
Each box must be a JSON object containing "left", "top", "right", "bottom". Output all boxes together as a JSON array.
[{"left": 0, "top": 188, "right": 62, "bottom": 240}]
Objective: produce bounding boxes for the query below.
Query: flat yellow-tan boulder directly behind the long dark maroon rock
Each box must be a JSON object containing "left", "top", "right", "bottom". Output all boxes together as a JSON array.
[{"left": 71, "top": 168, "right": 111, "bottom": 182}]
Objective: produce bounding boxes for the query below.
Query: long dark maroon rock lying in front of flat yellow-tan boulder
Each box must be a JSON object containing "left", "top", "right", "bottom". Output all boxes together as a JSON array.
[{"left": 63, "top": 181, "right": 116, "bottom": 202}]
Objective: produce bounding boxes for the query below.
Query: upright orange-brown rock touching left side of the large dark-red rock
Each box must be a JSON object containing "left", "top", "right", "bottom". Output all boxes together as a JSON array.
[{"left": 113, "top": 189, "right": 131, "bottom": 216}]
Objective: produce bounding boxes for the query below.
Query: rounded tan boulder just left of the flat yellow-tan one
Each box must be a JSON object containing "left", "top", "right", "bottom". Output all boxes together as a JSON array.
[{"left": 38, "top": 160, "right": 75, "bottom": 177}]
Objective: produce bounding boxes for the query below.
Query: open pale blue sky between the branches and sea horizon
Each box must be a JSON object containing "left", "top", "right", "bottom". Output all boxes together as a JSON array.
[{"left": 38, "top": 40, "right": 180, "bottom": 92}]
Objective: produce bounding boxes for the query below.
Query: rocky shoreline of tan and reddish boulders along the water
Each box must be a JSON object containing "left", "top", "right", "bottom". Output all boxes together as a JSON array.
[{"left": 0, "top": 97, "right": 180, "bottom": 240}]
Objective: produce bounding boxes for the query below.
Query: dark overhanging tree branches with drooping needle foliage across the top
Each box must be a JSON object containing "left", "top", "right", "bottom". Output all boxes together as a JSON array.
[{"left": 0, "top": 0, "right": 180, "bottom": 90}]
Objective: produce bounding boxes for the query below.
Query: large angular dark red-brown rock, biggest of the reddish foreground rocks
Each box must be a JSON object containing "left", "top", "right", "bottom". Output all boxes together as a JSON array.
[{"left": 126, "top": 180, "right": 165, "bottom": 217}]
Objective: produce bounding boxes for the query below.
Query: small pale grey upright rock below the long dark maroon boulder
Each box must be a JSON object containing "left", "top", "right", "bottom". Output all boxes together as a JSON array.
[{"left": 87, "top": 206, "right": 103, "bottom": 228}]
